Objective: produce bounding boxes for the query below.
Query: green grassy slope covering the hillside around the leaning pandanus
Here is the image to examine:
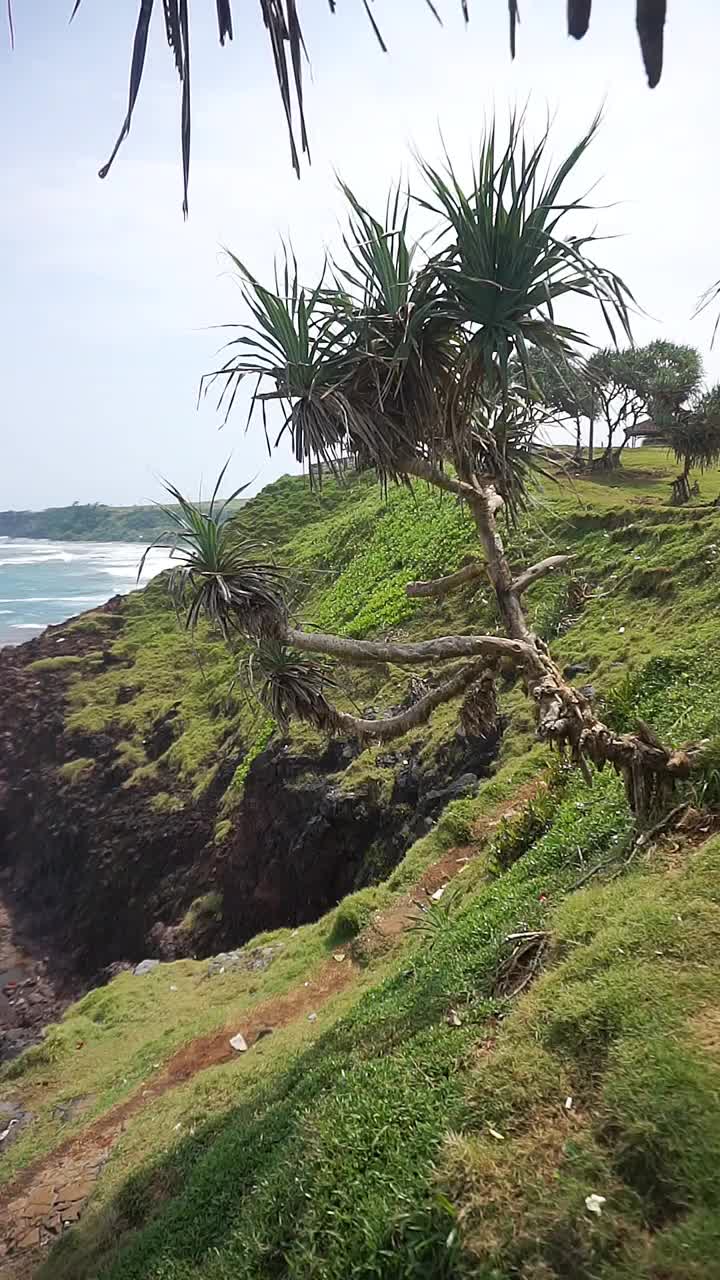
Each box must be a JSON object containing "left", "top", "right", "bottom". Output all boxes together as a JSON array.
[{"left": 3, "top": 451, "right": 720, "bottom": 1280}]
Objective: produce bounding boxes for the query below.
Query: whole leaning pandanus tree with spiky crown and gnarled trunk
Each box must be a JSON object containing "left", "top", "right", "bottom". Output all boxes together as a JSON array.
[{"left": 162, "top": 120, "right": 692, "bottom": 814}]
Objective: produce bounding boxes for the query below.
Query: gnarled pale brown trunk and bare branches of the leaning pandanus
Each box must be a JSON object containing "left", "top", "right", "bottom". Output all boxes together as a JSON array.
[{"left": 283, "top": 456, "right": 702, "bottom": 820}]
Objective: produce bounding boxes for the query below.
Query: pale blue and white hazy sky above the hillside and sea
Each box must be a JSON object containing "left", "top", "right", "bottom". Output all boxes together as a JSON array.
[{"left": 0, "top": 0, "right": 720, "bottom": 508}]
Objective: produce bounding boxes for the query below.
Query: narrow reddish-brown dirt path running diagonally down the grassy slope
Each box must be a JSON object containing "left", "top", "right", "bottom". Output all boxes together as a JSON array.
[{"left": 0, "top": 781, "right": 542, "bottom": 1280}]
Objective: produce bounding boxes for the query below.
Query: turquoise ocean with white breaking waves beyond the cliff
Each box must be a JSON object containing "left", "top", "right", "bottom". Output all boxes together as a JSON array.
[{"left": 0, "top": 538, "right": 169, "bottom": 648}]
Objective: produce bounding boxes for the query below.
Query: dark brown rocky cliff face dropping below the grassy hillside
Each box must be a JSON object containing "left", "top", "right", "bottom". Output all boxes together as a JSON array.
[{"left": 0, "top": 598, "right": 500, "bottom": 1008}]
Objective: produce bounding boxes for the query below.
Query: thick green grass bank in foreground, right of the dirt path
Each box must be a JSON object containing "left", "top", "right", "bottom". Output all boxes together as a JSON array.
[{"left": 37, "top": 778, "right": 720, "bottom": 1280}]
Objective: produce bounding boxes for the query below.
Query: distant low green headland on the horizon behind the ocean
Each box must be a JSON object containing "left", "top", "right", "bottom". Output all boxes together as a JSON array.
[{"left": 0, "top": 499, "right": 245, "bottom": 543}]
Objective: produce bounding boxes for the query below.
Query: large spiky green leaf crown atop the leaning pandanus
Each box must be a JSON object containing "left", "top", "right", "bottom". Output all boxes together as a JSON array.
[{"left": 206, "top": 116, "right": 632, "bottom": 506}]
